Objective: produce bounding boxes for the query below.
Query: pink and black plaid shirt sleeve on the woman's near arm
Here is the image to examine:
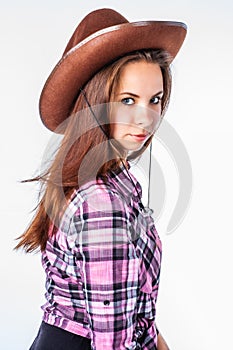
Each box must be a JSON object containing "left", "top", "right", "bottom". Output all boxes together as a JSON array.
[{"left": 67, "top": 185, "right": 139, "bottom": 350}]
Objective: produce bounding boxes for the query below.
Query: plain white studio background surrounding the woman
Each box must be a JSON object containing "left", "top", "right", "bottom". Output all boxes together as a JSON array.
[{"left": 0, "top": 0, "right": 233, "bottom": 350}]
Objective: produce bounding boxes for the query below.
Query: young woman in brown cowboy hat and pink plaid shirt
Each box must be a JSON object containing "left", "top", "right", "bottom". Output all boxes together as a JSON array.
[{"left": 17, "top": 9, "right": 186, "bottom": 350}]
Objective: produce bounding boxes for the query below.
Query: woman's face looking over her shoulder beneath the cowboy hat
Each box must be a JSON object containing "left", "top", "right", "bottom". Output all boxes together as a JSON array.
[{"left": 111, "top": 61, "right": 163, "bottom": 151}]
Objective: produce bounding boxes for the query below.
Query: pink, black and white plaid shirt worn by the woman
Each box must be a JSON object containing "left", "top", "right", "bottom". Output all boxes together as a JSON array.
[{"left": 42, "top": 165, "right": 161, "bottom": 350}]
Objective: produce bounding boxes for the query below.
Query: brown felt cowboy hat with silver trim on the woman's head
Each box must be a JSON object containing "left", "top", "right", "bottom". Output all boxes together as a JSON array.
[{"left": 40, "top": 9, "right": 187, "bottom": 131}]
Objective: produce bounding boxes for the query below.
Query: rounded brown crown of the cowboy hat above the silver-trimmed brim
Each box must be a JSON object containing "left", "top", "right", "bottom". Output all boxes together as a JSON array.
[{"left": 63, "top": 8, "right": 129, "bottom": 56}]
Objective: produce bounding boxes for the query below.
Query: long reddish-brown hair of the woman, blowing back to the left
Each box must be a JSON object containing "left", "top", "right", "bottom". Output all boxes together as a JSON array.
[{"left": 15, "top": 49, "right": 171, "bottom": 252}]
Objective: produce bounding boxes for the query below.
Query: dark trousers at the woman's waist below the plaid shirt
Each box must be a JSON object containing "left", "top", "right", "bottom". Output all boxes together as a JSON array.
[{"left": 29, "top": 322, "right": 91, "bottom": 350}]
